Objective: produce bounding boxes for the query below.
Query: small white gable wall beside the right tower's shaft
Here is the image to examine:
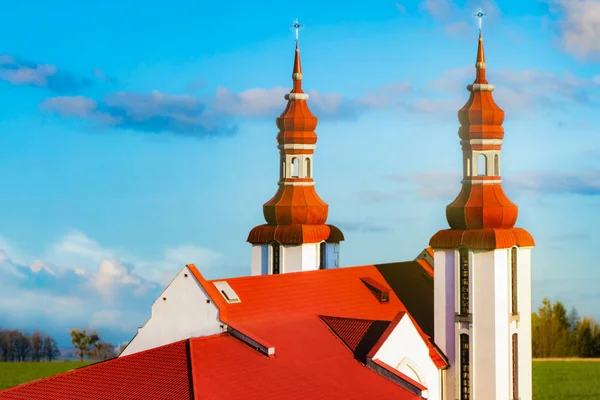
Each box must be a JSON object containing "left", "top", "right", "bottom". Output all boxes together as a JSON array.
[{"left": 373, "top": 315, "right": 441, "bottom": 400}]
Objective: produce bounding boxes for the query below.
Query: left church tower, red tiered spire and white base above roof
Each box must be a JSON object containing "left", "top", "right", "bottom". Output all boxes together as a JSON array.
[{"left": 248, "top": 36, "right": 344, "bottom": 275}]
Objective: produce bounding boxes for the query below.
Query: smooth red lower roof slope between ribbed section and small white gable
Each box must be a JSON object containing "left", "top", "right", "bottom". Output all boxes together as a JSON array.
[{"left": 190, "top": 330, "right": 420, "bottom": 400}]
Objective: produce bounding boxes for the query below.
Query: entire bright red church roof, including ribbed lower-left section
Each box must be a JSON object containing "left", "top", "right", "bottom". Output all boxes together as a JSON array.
[{"left": 0, "top": 266, "right": 438, "bottom": 400}]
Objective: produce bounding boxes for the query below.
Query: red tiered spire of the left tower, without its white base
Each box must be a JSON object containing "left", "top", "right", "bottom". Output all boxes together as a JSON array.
[{"left": 248, "top": 42, "right": 344, "bottom": 244}]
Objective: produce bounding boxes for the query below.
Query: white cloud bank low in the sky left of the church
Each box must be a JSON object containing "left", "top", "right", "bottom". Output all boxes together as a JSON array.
[{"left": 0, "top": 230, "right": 223, "bottom": 344}]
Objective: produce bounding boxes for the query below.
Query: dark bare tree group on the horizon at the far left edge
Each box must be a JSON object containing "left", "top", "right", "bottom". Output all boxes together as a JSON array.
[{"left": 0, "top": 328, "right": 60, "bottom": 362}]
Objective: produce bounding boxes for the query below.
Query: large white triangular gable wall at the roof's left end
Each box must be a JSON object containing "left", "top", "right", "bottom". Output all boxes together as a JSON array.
[{"left": 121, "top": 267, "right": 222, "bottom": 356}]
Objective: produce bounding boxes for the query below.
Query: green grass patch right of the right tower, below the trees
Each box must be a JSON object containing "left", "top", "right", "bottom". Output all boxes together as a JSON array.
[{"left": 533, "top": 360, "right": 600, "bottom": 400}]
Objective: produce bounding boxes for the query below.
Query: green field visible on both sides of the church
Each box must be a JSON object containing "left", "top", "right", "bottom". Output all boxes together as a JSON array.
[{"left": 0, "top": 360, "right": 600, "bottom": 400}]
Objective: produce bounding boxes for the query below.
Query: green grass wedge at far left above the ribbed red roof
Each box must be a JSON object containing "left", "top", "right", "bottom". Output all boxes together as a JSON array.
[{"left": 0, "top": 361, "right": 92, "bottom": 390}]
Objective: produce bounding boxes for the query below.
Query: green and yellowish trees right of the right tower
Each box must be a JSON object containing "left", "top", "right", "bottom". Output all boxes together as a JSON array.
[{"left": 531, "top": 298, "right": 600, "bottom": 358}]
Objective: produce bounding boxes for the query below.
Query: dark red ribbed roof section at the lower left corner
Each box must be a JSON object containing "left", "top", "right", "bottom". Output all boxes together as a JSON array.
[{"left": 0, "top": 341, "right": 193, "bottom": 400}]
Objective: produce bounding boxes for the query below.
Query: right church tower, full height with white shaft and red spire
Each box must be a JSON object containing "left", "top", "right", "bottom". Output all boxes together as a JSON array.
[{"left": 430, "top": 29, "right": 535, "bottom": 400}]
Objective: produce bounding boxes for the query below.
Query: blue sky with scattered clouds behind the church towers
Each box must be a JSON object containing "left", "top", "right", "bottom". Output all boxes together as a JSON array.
[{"left": 0, "top": 0, "right": 600, "bottom": 344}]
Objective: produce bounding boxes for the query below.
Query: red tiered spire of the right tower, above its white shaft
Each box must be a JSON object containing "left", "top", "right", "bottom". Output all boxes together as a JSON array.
[{"left": 430, "top": 32, "right": 534, "bottom": 248}]
